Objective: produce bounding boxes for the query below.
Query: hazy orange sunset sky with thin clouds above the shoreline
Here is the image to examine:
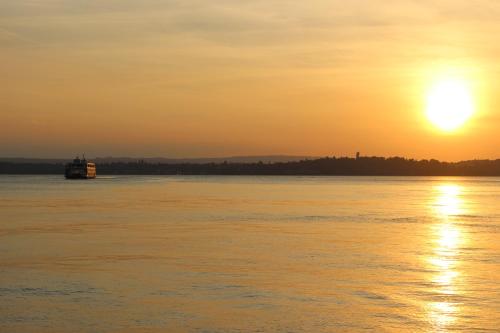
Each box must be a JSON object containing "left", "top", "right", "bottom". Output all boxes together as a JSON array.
[{"left": 0, "top": 0, "right": 500, "bottom": 161}]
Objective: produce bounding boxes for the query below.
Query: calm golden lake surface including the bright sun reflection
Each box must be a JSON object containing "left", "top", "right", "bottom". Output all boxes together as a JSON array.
[{"left": 0, "top": 176, "right": 500, "bottom": 332}]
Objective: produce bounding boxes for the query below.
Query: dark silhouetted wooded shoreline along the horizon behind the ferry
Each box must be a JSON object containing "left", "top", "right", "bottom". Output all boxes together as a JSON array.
[{"left": 0, "top": 157, "right": 500, "bottom": 177}]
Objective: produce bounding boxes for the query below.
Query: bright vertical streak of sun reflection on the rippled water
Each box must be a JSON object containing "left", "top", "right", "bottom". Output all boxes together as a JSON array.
[{"left": 427, "top": 184, "right": 465, "bottom": 331}]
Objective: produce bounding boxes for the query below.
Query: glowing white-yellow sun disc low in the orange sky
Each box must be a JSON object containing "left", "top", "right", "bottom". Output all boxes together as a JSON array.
[{"left": 426, "top": 79, "right": 474, "bottom": 132}]
